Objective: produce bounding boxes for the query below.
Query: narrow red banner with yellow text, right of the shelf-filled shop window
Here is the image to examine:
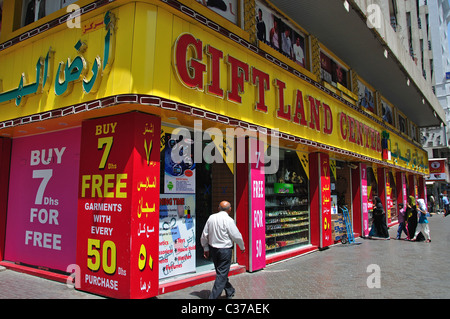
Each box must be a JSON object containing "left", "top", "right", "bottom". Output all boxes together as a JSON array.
[{"left": 319, "top": 154, "right": 334, "bottom": 247}]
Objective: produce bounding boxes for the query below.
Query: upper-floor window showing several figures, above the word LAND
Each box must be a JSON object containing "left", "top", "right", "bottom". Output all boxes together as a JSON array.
[{"left": 256, "top": 1, "right": 306, "bottom": 67}]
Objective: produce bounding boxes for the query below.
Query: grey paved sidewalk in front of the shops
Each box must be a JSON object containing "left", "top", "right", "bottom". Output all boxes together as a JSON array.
[{"left": 0, "top": 215, "right": 450, "bottom": 299}]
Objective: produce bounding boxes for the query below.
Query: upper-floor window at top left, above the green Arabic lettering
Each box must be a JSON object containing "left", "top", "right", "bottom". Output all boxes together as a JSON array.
[{"left": 21, "top": 0, "right": 77, "bottom": 26}]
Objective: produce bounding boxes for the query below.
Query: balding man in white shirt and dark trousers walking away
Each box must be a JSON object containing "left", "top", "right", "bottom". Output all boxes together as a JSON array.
[{"left": 200, "top": 201, "right": 245, "bottom": 299}]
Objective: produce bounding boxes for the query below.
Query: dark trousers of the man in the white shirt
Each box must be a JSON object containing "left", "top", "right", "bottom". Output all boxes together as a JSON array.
[{"left": 209, "top": 246, "right": 235, "bottom": 299}]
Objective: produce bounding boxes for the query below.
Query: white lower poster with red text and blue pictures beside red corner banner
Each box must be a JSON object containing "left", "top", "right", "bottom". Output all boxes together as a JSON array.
[{"left": 159, "top": 194, "right": 195, "bottom": 278}]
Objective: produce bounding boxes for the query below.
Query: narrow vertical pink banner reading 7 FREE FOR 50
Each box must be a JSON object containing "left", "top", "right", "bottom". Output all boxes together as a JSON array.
[{"left": 249, "top": 138, "right": 266, "bottom": 271}]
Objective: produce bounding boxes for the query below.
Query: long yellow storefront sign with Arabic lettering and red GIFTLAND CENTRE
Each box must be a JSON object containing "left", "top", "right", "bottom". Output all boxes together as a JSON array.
[{"left": 0, "top": 2, "right": 428, "bottom": 174}]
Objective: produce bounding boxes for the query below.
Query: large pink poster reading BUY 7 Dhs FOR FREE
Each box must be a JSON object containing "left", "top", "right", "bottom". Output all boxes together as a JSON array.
[{"left": 5, "top": 128, "right": 81, "bottom": 271}]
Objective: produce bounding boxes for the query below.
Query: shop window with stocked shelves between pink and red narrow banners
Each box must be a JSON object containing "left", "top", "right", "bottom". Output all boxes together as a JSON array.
[{"left": 266, "top": 149, "right": 310, "bottom": 255}]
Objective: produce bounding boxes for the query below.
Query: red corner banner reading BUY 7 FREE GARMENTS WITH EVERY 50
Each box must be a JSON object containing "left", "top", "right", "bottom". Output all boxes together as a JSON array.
[{"left": 77, "top": 112, "right": 161, "bottom": 298}]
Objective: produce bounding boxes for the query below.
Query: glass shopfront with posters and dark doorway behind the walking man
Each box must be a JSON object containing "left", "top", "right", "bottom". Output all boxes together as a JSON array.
[{"left": 159, "top": 126, "right": 235, "bottom": 279}]
